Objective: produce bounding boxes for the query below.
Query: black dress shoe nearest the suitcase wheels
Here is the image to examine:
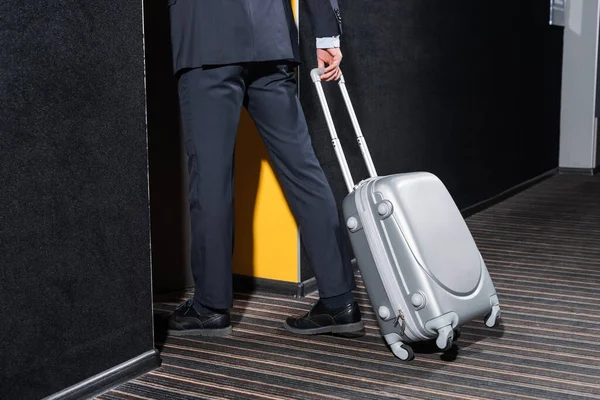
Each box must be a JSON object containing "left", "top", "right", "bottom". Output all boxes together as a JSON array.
[{"left": 284, "top": 300, "right": 364, "bottom": 335}]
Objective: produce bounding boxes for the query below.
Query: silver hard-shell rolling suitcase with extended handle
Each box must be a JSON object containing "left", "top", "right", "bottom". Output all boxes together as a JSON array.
[{"left": 311, "top": 68, "right": 500, "bottom": 361}]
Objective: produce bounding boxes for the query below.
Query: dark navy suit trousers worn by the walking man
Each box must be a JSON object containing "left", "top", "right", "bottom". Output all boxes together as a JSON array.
[{"left": 178, "top": 63, "right": 354, "bottom": 309}]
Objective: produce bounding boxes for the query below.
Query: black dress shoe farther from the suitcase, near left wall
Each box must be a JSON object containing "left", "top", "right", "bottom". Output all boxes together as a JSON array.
[{"left": 167, "top": 299, "right": 232, "bottom": 336}]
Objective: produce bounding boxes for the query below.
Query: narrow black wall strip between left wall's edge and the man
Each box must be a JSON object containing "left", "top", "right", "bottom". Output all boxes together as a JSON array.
[{"left": 144, "top": 1, "right": 194, "bottom": 293}]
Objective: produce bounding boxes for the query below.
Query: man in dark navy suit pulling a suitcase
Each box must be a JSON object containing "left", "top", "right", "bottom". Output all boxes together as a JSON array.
[{"left": 168, "top": 0, "right": 363, "bottom": 336}]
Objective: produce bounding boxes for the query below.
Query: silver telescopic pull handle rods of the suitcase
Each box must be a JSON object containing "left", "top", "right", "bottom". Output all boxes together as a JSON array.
[{"left": 310, "top": 68, "right": 377, "bottom": 193}]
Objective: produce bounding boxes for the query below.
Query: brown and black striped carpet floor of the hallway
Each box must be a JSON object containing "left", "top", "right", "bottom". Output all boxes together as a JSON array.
[{"left": 100, "top": 176, "right": 600, "bottom": 400}]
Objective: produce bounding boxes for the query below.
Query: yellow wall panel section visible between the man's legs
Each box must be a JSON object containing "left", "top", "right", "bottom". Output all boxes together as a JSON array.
[{"left": 233, "top": 110, "right": 299, "bottom": 282}]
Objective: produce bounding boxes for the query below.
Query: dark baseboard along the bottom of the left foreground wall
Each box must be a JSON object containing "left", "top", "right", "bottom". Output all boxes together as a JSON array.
[{"left": 44, "top": 349, "right": 160, "bottom": 400}]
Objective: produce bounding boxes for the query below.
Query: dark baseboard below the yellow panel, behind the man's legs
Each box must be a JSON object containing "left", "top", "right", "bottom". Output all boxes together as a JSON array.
[{"left": 233, "top": 274, "right": 317, "bottom": 298}]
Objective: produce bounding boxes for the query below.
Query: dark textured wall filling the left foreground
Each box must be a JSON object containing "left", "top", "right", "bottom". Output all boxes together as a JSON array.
[{"left": 0, "top": 0, "right": 153, "bottom": 400}]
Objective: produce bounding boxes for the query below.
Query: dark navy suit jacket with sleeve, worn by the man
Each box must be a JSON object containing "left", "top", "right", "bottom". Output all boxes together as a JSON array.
[{"left": 168, "top": 0, "right": 342, "bottom": 73}]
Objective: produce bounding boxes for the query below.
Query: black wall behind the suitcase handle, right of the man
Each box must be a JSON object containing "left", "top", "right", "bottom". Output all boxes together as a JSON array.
[{"left": 300, "top": 0, "right": 562, "bottom": 279}]
